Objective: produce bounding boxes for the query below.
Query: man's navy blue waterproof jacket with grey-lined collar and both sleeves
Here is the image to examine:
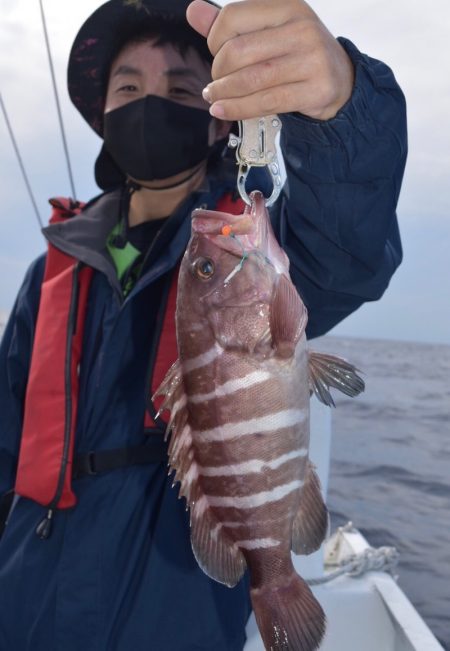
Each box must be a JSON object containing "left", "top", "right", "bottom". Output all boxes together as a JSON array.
[{"left": 0, "top": 41, "right": 406, "bottom": 651}]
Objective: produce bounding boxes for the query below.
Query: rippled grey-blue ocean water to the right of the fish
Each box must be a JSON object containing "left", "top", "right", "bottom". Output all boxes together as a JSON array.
[{"left": 311, "top": 337, "right": 450, "bottom": 651}]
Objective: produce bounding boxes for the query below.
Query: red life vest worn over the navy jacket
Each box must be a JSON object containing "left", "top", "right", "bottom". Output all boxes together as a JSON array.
[{"left": 14, "top": 194, "right": 244, "bottom": 513}]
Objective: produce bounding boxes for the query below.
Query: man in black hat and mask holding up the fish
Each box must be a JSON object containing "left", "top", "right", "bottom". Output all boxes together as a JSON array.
[{"left": 0, "top": 0, "right": 406, "bottom": 651}]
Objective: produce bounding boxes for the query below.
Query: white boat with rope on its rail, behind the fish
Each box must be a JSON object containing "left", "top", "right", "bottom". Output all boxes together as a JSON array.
[{"left": 244, "top": 398, "right": 444, "bottom": 651}]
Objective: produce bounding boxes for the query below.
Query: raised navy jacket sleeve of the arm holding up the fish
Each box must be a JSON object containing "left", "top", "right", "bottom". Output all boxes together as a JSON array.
[{"left": 273, "top": 38, "right": 407, "bottom": 337}]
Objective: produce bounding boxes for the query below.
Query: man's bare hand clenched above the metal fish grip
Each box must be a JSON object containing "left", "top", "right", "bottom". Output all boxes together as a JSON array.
[{"left": 187, "top": 0, "right": 354, "bottom": 121}]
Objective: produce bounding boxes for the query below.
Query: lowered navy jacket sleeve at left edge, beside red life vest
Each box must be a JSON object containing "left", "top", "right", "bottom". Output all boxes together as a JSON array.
[{"left": 0, "top": 256, "right": 45, "bottom": 496}]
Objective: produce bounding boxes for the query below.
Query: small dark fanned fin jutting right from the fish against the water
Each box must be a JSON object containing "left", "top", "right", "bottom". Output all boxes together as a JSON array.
[{"left": 309, "top": 351, "right": 365, "bottom": 407}]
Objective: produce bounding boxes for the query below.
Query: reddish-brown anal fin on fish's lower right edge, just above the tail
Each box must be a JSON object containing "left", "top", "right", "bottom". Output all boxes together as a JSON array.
[{"left": 292, "top": 462, "right": 329, "bottom": 554}]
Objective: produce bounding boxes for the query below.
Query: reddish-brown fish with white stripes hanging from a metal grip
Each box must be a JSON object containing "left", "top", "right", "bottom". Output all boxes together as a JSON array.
[{"left": 155, "top": 192, "right": 364, "bottom": 651}]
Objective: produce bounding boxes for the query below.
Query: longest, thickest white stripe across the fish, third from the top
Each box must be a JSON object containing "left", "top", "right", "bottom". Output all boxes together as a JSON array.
[{"left": 193, "top": 409, "right": 307, "bottom": 442}]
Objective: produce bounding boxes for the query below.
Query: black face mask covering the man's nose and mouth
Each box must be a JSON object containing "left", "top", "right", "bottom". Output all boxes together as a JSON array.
[{"left": 103, "top": 95, "right": 212, "bottom": 181}]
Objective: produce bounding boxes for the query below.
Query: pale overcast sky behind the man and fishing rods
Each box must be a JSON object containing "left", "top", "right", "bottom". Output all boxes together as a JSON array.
[{"left": 0, "top": 0, "right": 450, "bottom": 343}]
